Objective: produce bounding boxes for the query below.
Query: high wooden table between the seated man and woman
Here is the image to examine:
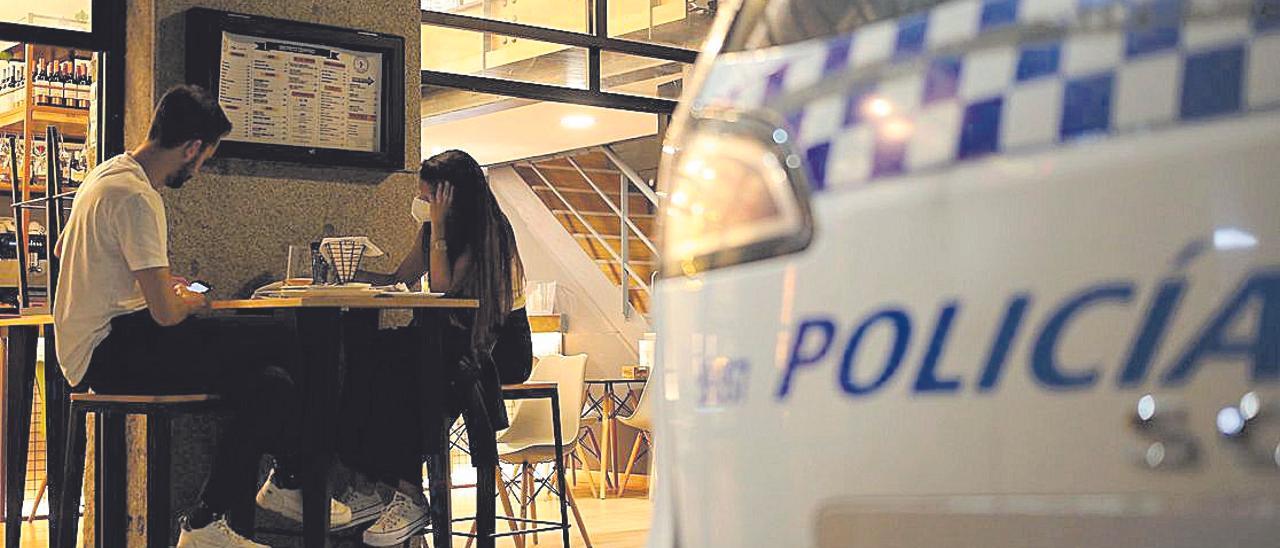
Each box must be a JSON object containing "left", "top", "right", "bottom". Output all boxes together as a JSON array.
[{"left": 212, "top": 293, "right": 479, "bottom": 547}]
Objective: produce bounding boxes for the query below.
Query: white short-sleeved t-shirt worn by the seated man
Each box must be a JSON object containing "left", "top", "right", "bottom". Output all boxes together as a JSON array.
[{"left": 54, "top": 154, "right": 169, "bottom": 387}]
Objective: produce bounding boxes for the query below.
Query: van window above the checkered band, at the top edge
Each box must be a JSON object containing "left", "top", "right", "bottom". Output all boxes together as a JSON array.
[{"left": 724, "top": 0, "right": 945, "bottom": 51}]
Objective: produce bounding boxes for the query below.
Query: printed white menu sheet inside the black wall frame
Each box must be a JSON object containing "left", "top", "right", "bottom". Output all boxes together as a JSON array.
[{"left": 218, "top": 31, "right": 383, "bottom": 152}]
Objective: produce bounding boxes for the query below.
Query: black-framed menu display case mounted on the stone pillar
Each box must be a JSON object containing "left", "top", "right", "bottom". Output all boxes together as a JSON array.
[{"left": 187, "top": 9, "right": 404, "bottom": 169}]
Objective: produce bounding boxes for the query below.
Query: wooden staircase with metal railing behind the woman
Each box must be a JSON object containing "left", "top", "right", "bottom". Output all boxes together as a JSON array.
[{"left": 512, "top": 146, "right": 658, "bottom": 315}]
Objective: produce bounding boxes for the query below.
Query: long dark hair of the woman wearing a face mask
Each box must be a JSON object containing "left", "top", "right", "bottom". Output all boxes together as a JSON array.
[{"left": 419, "top": 150, "right": 525, "bottom": 350}]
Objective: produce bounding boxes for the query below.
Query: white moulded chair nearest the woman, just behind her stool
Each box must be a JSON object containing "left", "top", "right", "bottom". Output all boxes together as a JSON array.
[{"left": 498, "top": 353, "right": 591, "bottom": 547}]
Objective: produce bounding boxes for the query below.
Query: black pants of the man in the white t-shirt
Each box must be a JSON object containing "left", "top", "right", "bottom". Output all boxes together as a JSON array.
[{"left": 76, "top": 310, "right": 298, "bottom": 513}]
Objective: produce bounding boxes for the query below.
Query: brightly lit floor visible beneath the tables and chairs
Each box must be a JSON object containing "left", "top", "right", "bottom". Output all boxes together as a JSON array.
[{"left": 0, "top": 476, "right": 652, "bottom": 548}]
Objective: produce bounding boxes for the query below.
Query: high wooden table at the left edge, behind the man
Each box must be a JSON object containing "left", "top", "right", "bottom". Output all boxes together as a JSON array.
[{"left": 0, "top": 314, "right": 70, "bottom": 548}]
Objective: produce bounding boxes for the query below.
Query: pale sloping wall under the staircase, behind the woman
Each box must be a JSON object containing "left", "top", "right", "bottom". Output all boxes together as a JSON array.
[{"left": 489, "top": 163, "right": 649, "bottom": 378}]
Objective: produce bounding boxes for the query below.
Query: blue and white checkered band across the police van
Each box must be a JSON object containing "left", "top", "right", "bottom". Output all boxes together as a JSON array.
[{"left": 716, "top": 0, "right": 1280, "bottom": 191}]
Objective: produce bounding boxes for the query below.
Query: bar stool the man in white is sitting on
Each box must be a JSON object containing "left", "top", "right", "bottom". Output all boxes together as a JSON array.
[{"left": 52, "top": 393, "right": 219, "bottom": 548}]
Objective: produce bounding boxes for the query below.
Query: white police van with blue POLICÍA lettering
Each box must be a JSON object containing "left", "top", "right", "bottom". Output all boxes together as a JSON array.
[{"left": 650, "top": 0, "right": 1280, "bottom": 548}]
